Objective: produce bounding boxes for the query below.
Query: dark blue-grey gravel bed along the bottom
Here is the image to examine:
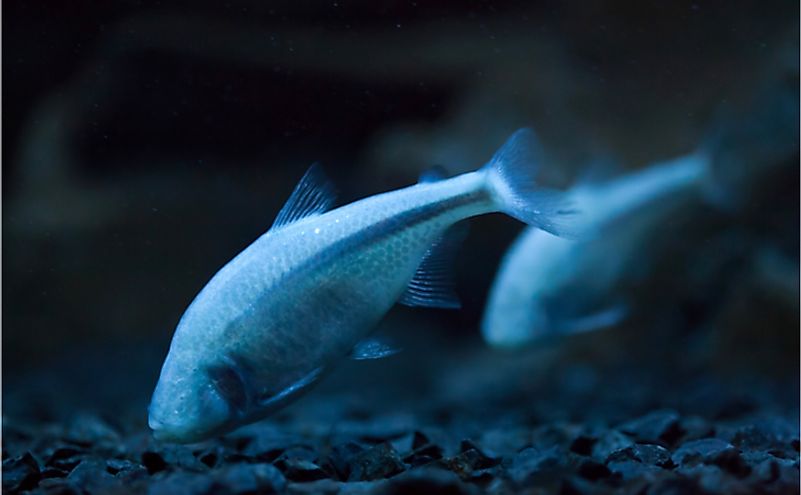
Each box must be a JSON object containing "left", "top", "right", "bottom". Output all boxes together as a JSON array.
[{"left": 3, "top": 360, "right": 799, "bottom": 494}]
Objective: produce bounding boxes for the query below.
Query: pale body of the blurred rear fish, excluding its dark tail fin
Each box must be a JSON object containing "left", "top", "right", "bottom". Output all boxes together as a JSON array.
[{"left": 481, "top": 149, "right": 712, "bottom": 348}]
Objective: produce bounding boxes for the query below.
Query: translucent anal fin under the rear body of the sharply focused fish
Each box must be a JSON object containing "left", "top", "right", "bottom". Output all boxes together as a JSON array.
[{"left": 398, "top": 223, "right": 467, "bottom": 309}]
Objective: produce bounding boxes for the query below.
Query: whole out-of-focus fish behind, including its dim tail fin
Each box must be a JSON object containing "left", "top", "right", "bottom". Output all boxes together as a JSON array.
[{"left": 482, "top": 74, "right": 799, "bottom": 348}]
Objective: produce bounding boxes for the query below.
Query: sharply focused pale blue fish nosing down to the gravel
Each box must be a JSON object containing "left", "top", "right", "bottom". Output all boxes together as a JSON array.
[{"left": 148, "top": 128, "right": 579, "bottom": 443}]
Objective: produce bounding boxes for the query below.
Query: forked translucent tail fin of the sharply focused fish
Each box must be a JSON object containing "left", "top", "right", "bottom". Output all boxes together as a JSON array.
[{"left": 484, "top": 128, "right": 578, "bottom": 238}]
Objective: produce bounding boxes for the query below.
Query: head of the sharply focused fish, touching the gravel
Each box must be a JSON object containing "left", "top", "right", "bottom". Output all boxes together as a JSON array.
[{"left": 148, "top": 355, "right": 242, "bottom": 443}]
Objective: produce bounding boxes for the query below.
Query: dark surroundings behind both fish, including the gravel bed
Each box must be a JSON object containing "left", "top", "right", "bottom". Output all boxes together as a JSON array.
[{"left": 2, "top": 0, "right": 800, "bottom": 493}]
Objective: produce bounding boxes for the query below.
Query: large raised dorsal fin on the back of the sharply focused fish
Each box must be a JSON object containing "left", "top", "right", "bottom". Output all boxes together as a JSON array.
[{"left": 270, "top": 163, "right": 336, "bottom": 230}]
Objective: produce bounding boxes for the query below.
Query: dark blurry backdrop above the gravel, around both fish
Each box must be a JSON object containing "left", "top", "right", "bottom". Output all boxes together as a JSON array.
[{"left": 2, "top": 0, "right": 799, "bottom": 472}]
